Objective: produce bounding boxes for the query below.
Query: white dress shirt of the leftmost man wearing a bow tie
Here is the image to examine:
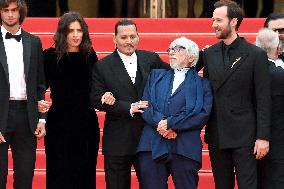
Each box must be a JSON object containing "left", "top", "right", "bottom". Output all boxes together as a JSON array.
[{"left": 1, "top": 26, "right": 27, "bottom": 100}]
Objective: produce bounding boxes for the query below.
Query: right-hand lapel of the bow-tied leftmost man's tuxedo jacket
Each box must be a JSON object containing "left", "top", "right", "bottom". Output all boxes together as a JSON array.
[{"left": 22, "top": 30, "right": 31, "bottom": 81}]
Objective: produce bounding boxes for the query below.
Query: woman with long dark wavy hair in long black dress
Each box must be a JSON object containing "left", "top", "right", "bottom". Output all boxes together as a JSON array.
[{"left": 44, "top": 12, "right": 99, "bottom": 189}]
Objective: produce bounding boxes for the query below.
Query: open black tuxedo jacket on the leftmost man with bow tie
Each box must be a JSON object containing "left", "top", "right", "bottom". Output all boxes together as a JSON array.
[{"left": 0, "top": 29, "right": 45, "bottom": 133}]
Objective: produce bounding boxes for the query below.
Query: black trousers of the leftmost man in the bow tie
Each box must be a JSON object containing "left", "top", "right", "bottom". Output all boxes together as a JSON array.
[{"left": 0, "top": 101, "right": 36, "bottom": 189}]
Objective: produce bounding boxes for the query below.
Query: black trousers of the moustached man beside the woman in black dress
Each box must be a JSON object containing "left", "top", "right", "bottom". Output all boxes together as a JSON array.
[{"left": 104, "top": 155, "right": 142, "bottom": 189}]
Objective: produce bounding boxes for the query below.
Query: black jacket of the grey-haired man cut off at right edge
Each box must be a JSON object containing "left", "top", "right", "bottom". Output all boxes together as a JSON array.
[{"left": 265, "top": 61, "right": 284, "bottom": 159}]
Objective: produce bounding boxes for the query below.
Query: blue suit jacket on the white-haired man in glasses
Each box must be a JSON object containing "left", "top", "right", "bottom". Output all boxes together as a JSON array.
[{"left": 137, "top": 68, "right": 212, "bottom": 162}]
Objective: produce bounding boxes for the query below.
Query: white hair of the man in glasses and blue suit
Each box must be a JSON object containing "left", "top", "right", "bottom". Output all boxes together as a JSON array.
[{"left": 170, "top": 37, "right": 199, "bottom": 67}]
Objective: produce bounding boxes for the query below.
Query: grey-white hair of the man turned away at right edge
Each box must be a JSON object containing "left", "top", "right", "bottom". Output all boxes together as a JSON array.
[{"left": 255, "top": 28, "right": 279, "bottom": 53}]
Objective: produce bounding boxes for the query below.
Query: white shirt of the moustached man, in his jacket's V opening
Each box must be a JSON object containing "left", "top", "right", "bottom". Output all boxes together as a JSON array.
[{"left": 117, "top": 50, "right": 137, "bottom": 84}]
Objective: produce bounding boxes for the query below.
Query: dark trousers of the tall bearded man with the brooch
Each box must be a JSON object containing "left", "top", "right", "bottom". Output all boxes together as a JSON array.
[{"left": 209, "top": 145, "right": 257, "bottom": 189}]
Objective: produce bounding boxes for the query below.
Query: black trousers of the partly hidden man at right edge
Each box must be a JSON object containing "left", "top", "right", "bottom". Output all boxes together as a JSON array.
[{"left": 258, "top": 159, "right": 284, "bottom": 189}]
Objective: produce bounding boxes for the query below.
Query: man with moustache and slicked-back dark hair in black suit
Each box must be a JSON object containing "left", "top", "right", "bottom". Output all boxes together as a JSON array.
[{"left": 91, "top": 20, "right": 169, "bottom": 189}]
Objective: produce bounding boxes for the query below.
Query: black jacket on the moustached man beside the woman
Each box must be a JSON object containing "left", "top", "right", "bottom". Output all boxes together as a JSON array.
[{"left": 90, "top": 50, "right": 169, "bottom": 156}]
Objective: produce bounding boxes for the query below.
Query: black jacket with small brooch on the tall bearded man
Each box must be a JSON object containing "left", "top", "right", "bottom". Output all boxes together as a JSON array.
[{"left": 198, "top": 38, "right": 271, "bottom": 149}]
